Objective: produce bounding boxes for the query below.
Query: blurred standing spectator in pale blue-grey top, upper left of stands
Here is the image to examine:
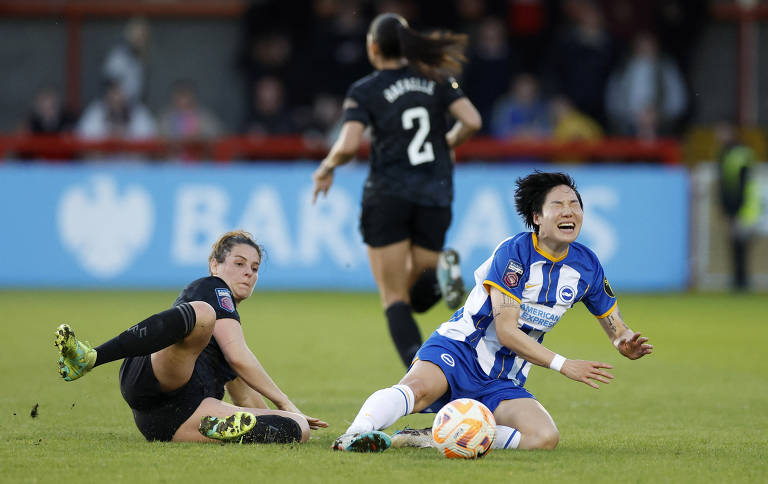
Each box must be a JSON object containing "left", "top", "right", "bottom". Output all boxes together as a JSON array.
[{"left": 103, "top": 17, "right": 149, "bottom": 103}]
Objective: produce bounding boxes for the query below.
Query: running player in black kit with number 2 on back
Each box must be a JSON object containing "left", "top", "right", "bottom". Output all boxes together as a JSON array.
[{"left": 312, "top": 14, "right": 481, "bottom": 366}]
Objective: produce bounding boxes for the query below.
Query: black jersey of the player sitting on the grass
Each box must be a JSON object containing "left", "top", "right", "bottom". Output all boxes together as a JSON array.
[{"left": 173, "top": 276, "right": 240, "bottom": 391}]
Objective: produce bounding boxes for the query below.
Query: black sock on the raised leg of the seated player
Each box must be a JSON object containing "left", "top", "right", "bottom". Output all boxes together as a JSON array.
[{"left": 94, "top": 303, "right": 196, "bottom": 366}]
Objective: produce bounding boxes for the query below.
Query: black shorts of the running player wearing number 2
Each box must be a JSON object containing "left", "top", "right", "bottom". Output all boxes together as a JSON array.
[{"left": 360, "top": 196, "right": 452, "bottom": 251}]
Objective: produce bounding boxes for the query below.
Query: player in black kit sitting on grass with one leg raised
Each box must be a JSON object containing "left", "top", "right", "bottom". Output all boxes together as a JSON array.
[{"left": 55, "top": 231, "right": 328, "bottom": 443}]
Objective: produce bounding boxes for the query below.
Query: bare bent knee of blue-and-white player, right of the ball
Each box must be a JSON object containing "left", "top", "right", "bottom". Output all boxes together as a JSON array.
[{"left": 493, "top": 398, "right": 560, "bottom": 449}]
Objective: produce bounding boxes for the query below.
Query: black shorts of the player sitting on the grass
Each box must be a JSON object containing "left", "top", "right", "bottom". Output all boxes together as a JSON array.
[{"left": 120, "top": 355, "right": 224, "bottom": 441}]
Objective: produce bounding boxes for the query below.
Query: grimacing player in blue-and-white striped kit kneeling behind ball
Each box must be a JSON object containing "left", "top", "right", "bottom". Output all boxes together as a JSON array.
[{"left": 333, "top": 171, "right": 653, "bottom": 452}]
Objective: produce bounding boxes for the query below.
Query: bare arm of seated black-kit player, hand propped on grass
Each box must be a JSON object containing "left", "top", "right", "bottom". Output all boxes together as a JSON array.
[{"left": 213, "top": 319, "right": 328, "bottom": 429}]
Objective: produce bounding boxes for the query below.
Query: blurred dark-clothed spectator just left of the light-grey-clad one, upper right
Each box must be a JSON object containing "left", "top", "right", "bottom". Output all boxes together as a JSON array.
[{"left": 545, "top": 0, "right": 615, "bottom": 124}]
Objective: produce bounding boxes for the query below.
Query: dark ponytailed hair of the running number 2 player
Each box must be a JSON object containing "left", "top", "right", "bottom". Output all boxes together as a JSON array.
[{"left": 368, "top": 13, "right": 467, "bottom": 79}]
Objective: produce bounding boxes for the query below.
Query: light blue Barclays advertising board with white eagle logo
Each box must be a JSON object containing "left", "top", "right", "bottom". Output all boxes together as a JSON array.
[{"left": 0, "top": 163, "right": 689, "bottom": 291}]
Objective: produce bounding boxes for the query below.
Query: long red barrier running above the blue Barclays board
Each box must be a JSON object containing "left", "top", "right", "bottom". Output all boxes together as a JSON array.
[{"left": 0, "top": 135, "right": 681, "bottom": 164}]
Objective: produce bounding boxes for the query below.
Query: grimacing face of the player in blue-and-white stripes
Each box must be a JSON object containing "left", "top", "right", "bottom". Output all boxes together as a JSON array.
[{"left": 533, "top": 185, "right": 584, "bottom": 248}]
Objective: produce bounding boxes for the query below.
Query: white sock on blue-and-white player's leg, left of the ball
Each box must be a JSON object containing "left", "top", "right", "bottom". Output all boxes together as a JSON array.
[{"left": 347, "top": 385, "right": 414, "bottom": 434}]
